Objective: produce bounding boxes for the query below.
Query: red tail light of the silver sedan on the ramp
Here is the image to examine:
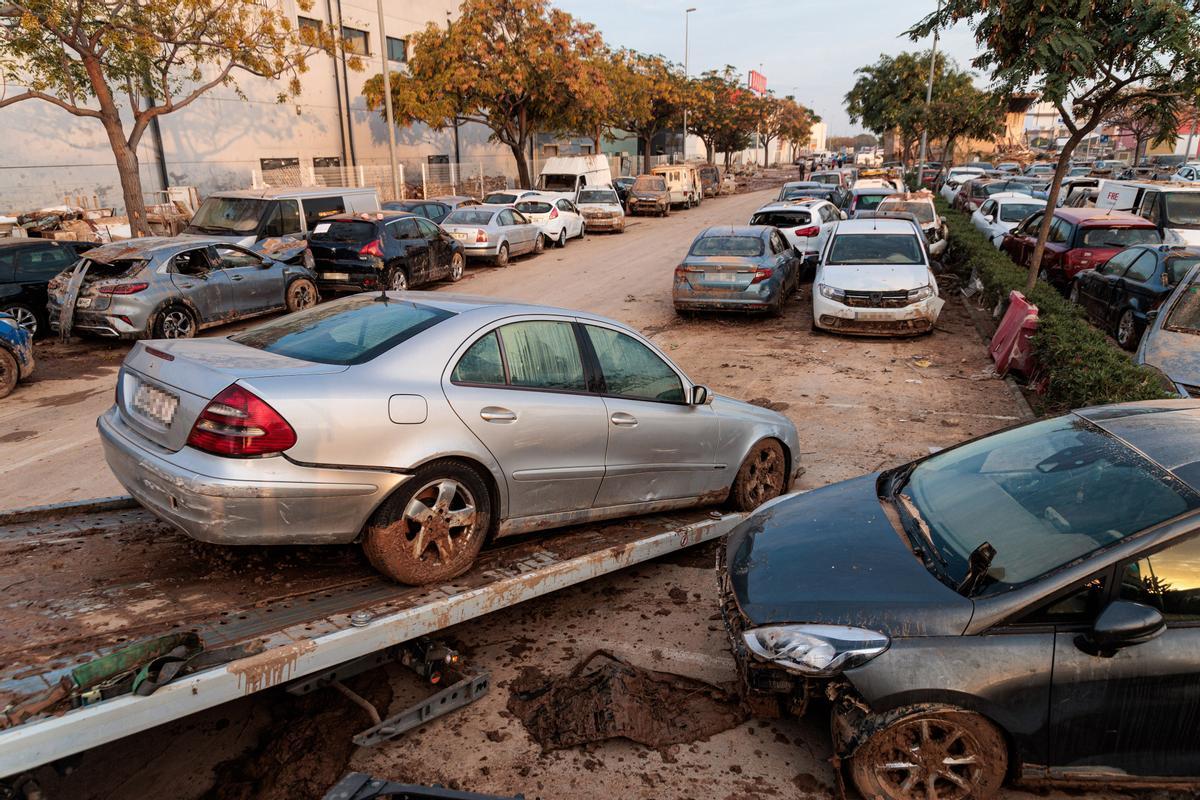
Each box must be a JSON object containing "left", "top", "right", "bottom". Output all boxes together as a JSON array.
[{"left": 187, "top": 384, "right": 296, "bottom": 458}]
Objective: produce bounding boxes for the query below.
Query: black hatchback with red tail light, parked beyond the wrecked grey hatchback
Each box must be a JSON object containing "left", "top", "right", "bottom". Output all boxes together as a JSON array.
[{"left": 308, "top": 211, "right": 467, "bottom": 293}]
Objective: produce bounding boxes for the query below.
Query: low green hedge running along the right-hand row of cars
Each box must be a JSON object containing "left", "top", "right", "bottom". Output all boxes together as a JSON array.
[{"left": 937, "top": 199, "right": 1174, "bottom": 414}]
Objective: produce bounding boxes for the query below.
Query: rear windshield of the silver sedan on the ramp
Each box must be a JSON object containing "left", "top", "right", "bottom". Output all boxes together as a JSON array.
[{"left": 229, "top": 293, "right": 454, "bottom": 365}]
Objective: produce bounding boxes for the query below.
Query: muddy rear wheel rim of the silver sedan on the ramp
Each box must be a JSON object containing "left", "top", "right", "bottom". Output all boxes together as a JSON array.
[{"left": 404, "top": 477, "right": 479, "bottom": 564}]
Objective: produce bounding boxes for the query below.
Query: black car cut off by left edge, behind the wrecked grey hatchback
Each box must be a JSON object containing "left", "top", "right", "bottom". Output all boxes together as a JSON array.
[{"left": 0, "top": 239, "right": 96, "bottom": 336}]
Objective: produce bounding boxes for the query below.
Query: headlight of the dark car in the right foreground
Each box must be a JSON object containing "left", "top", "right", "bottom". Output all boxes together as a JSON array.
[{"left": 742, "top": 625, "right": 892, "bottom": 678}]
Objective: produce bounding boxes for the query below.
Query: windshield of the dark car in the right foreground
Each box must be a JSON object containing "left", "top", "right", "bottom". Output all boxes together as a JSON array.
[{"left": 902, "top": 414, "right": 1200, "bottom": 591}]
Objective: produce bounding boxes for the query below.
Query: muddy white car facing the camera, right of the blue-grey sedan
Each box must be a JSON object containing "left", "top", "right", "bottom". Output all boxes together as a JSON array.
[{"left": 812, "top": 212, "right": 944, "bottom": 336}]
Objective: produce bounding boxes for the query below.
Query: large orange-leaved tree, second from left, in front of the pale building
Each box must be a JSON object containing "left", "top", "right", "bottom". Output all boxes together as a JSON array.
[{"left": 362, "top": 0, "right": 604, "bottom": 186}]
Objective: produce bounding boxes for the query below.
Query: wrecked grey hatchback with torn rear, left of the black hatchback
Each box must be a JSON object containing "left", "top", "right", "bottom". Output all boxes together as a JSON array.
[{"left": 47, "top": 236, "right": 319, "bottom": 339}]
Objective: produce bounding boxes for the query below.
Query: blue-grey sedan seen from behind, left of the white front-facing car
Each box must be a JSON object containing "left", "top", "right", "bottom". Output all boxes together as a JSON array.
[{"left": 672, "top": 225, "right": 800, "bottom": 315}]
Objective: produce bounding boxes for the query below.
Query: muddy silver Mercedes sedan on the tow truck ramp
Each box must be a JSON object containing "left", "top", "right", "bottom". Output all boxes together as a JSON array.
[{"left": 98, "top": 291, "right": 800, "bottom": 583}]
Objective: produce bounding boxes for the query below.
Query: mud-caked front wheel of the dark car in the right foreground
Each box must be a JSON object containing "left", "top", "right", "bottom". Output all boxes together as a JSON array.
[{"left": 850, "top": 710, "right": 1008, "bottom": 800}]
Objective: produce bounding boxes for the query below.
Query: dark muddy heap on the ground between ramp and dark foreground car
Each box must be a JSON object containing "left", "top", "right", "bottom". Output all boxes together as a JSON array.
[{"left": 508, "top": 650, "right": 750, "bottom": 751}]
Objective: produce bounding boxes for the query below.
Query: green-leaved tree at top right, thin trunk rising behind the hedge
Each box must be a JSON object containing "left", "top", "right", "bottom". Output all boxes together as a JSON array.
[{"left": 908, "top": 0, "right": 1200, "bottom": 290}]
